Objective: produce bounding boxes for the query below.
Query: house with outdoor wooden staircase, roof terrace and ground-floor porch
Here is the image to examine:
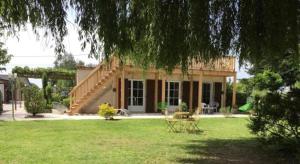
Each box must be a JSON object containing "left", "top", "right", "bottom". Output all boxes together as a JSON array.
[{"left": 69, "top": 57, "right": 236, "bottom": 114}]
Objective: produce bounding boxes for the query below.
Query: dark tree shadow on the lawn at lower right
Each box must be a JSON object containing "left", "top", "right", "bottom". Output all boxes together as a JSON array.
[{"left": 175, "top": 139, "right": 299, "bottom": 164}]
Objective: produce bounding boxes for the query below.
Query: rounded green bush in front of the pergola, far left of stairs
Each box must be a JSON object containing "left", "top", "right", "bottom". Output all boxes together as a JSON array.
[{"left": 23, "top": 85, "right": 46, "bottom": 116}]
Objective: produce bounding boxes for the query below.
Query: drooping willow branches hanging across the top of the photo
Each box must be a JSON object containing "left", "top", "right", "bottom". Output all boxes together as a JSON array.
[{"left": 0, "top": 0, "right": 299, "bottom": 70}]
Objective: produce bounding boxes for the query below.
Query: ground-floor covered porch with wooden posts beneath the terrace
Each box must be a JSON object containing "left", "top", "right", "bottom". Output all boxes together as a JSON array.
[{"left": 115, "top": 67, "right": 236, "bottom": 113}]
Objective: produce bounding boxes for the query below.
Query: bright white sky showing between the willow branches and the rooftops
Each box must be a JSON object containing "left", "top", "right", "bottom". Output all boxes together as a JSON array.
[{"left": 0, "top": 19, "right": 249, "bottom": 87}]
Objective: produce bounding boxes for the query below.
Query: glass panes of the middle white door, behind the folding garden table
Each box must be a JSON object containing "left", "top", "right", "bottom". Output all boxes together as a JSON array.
[{"left": 165, "top": 82, "right": 179, "bottom": 106}]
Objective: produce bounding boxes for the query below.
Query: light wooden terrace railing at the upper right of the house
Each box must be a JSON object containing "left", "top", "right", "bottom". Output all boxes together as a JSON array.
[{"left": 189, "top": 57, "right": 235, "bottom": 72}]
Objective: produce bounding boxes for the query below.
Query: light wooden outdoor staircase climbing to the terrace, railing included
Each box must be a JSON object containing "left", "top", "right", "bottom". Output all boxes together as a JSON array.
[{"left": 67, "top": 57, "right": 119, "bottom": 115}]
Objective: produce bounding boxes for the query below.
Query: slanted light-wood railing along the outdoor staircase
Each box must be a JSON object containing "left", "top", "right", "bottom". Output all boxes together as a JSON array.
[{"left": 69, "top": 57, "right": 119, "bottom": 107}]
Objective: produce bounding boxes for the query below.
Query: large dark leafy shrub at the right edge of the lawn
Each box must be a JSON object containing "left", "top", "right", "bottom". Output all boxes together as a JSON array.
[{"left": 249, "top": 70, "right": 300, "bottom": 155}]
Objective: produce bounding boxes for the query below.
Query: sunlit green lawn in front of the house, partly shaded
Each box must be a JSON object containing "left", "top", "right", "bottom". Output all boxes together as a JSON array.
[{"left": 0, "top": 118, "right": 296, "bottom": 163}]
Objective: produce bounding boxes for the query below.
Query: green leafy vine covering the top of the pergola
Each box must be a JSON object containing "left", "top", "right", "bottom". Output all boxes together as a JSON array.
[{"left": 12, "top": 66, "right": 76, "bottom": 80}]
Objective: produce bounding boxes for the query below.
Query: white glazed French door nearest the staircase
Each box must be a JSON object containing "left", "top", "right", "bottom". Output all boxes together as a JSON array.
[{"left": 127, "top": 80, "right": 145, "bottom": 112}]
